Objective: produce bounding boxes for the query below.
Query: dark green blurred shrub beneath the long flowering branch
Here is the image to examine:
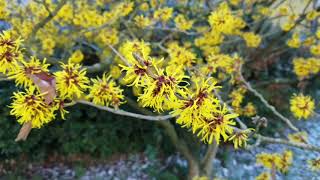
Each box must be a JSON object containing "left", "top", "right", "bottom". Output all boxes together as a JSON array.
[{"left": 0, "top": 82, "right": 172, "bottom": 160}]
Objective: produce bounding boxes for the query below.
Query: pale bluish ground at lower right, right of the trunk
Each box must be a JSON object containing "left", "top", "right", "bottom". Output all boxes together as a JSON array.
[{"left": 214, "top": 117, "right": 320, "bottom": 180}]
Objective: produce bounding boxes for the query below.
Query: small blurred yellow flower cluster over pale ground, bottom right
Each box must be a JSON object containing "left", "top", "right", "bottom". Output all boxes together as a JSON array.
[{"left": 256, "top": 151, "right": 293, "bottom": 173}]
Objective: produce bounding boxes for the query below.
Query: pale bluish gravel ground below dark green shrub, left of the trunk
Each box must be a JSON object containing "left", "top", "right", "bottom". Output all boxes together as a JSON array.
[{"left": 35, "top": 155, "right": 153, "bottom": 180}]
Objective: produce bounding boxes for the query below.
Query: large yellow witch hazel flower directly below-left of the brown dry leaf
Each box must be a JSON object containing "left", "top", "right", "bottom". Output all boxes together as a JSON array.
[{"left": 10, "top": 86, "right": 55, "bottom": 128}]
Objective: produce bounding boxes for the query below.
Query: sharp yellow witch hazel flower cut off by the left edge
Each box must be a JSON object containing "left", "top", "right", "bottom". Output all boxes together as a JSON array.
[{"left": 0, "top": 31, "right": 22, "bottom": 74}]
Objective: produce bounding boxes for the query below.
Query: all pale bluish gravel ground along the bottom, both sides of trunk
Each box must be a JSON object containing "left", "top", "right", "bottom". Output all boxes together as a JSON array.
[{"left": 29, "top": 118, "right": 320, "bottom": 180}]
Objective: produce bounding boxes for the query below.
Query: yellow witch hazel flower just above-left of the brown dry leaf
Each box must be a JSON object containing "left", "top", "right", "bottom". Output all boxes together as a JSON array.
[{"left": 8, "top": 57, "right": 50, "bottom": 87}]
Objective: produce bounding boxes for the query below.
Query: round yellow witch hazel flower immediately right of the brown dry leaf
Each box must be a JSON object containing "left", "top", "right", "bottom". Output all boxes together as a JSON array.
[{"left": 54, "top": 62, "right": 89, "bottom": 99}]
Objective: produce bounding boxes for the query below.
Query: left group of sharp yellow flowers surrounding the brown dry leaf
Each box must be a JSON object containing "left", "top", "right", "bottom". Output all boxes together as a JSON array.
[{"left": 0, "top": 31, "right": 124, "bottom": 128}]
